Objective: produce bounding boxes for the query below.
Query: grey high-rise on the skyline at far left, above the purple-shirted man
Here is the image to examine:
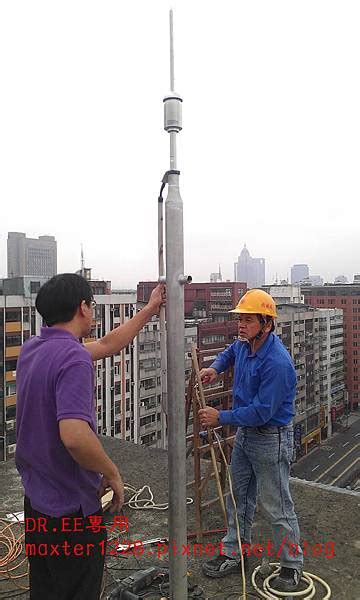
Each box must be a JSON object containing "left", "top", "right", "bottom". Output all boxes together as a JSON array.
[{"left": 7, "top": 231, "right": 57, "bottom": 279}]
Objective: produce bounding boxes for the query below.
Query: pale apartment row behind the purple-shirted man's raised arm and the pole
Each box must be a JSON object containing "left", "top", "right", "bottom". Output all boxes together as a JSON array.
[{"left": 85, "top": 291, "right": 197, "bottom": 448}]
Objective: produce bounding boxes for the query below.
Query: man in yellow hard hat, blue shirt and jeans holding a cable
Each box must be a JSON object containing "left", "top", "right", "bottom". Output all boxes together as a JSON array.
[{"left": 199, "top": 289, "right": 303, "bottom": 591}]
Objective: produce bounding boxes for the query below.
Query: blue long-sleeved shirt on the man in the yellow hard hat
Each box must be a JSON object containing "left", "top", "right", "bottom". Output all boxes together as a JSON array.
[{"left": 211, "top": 333, "right": 296, "bottom": 427}]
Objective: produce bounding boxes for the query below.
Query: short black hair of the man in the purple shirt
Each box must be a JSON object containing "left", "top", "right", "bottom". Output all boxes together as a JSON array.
[{"left": 35, "top": 273, "right": 93, "bottom": 327}]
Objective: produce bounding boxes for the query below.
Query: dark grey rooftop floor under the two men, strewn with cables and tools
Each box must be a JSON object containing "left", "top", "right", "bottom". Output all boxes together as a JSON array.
[{"left": 0, "top": 437, "right": 360, "bottom": 600}]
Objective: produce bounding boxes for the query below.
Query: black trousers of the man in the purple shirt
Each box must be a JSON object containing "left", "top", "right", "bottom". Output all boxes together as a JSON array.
[{"left": 24, "top": 497, "right": 107, "bottom": 600}]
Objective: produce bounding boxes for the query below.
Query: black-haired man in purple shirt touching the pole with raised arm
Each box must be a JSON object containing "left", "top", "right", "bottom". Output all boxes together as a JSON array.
[{"left": 16, "top": 273, "right": 165, "bottom": 600}]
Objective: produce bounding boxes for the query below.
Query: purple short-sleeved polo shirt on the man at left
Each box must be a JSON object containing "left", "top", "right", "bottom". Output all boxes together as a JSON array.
[{"left": 16, "top": 327, "right": 101, "bottom": 517}]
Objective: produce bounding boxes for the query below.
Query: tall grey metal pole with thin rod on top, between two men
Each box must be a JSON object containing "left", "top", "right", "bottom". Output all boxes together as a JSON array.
[{"left": 164, "top": 11, "right": 188, "bottom": 600}]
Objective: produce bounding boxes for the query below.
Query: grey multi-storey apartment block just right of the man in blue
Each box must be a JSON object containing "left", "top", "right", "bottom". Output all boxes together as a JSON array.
[{"left": 276, "top": 304, "right": 346, "bottom": 453}]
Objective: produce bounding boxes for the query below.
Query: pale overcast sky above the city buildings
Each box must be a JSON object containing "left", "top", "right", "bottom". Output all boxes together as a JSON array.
[{"left": 0, "top": 0, "right": 360, "bottom": 287}]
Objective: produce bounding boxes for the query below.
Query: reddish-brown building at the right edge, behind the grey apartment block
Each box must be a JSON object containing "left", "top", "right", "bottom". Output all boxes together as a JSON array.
[{"left": 301, "top": 283, "right": 360, "bottom": 412}]
